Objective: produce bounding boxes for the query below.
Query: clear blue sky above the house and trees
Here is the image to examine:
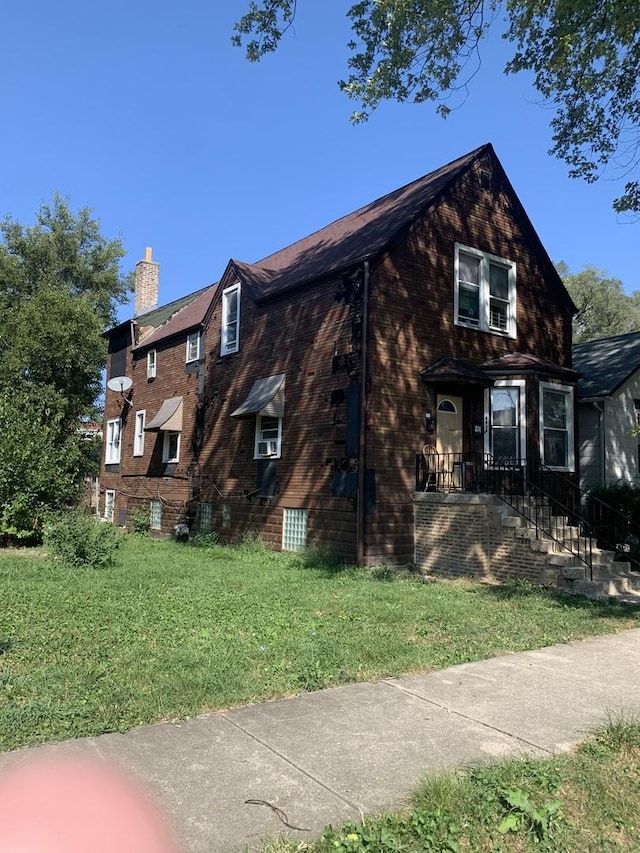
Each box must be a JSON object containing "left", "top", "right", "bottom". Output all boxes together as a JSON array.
[{"left": 0, "top": 0, "right": 640, "bottom": 319}]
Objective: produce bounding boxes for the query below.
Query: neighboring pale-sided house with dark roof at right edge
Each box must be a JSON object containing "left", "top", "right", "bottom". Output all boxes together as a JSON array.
[{"left": 573, "top": 332, "right": 640, "bottom": 489}]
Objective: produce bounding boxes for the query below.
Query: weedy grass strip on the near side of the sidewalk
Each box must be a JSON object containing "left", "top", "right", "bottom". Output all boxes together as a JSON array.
[{"left": 263, "top": 717, "right": 640, "bottom": 853}]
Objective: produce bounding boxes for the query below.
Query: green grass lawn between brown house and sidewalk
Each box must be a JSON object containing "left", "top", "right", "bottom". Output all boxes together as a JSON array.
[{"left": 0, "top": 536, "right": 640, "bottom": 750}]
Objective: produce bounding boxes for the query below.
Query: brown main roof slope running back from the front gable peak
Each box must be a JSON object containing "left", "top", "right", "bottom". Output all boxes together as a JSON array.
[{"left": 231, "top": 144, "right": 490, "bottom": 299}]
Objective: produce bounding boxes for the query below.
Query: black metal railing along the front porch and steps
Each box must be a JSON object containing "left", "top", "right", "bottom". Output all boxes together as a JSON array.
[{"left": 415, "top": 452, "right": 629, "bottom": 579}]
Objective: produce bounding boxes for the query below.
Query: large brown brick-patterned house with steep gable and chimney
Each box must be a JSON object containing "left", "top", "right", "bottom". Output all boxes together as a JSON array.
[{"left": 102, "top": 145, "right": 577, "bottom": 563}]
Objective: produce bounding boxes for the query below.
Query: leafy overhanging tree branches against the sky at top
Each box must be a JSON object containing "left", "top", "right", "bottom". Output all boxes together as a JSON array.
[{"left": 233, "top": 0, "right": 640, "bottom": 212}]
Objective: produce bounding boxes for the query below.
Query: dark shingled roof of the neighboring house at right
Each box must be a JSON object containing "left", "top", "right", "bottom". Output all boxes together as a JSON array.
[{"left": 573, "top": 332, "right": 640, "bottom": 399}]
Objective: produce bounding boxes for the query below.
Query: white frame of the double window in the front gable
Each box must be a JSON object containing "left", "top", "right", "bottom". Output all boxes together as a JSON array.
[{"left": 453, "top": 243, "right": 516, "bottom": 338}]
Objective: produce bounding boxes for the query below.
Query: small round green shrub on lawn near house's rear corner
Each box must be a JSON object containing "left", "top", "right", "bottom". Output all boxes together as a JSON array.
[{"left": 45, "top": 509, "right": 122, "bottom": 568}]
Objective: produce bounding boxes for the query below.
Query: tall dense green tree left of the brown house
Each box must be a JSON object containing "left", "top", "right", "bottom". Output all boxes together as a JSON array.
[{"left": 0, "top": 196, "right": 130, "bottom": 541}]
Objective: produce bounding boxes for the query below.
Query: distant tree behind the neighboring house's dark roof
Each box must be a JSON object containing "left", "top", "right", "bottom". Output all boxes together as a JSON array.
[{"left": 557, "top": 262, "right": 640, "bottom": 344}]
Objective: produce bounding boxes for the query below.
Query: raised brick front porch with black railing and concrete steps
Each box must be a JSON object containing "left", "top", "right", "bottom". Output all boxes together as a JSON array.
[{"left": 414, "top": 445, "right": 640, "bottom": 594}]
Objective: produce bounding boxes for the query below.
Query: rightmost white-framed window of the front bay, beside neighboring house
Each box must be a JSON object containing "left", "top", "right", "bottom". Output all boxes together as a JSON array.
[{"left": 540, "top": 382, "right": 575, "bottom": 471}]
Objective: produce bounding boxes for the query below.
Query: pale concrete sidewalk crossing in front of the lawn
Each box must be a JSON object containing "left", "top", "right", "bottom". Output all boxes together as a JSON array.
[{"left": 0, "top": 629, "right": 640, "bottom": 853}]
